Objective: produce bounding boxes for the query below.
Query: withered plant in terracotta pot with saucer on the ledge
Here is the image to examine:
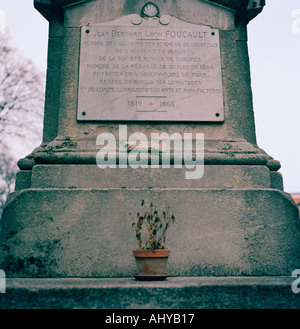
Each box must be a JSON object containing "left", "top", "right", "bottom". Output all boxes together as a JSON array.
[{"left": 130, "top": 200, "right": 175, "bottom": 280}]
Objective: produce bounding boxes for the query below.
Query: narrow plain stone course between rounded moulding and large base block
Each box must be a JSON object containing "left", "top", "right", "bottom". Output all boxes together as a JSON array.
[{"left": 31, "top": 165, "right": 271, "bottom": 188}]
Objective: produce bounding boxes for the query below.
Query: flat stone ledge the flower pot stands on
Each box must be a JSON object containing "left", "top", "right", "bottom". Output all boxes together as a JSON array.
[{"left": 0, "top": 276, "right": 300, "bottom": 309}]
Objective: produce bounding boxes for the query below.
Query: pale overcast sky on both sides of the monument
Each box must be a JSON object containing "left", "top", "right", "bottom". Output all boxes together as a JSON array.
[{"left": 0, "top": 0, "right": 300, "bottom": 192}]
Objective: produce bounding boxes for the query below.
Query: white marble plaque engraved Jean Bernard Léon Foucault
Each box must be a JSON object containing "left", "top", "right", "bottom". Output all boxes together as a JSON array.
[{"left": 78, "top": 25, "right": 224, "bottom": 121}]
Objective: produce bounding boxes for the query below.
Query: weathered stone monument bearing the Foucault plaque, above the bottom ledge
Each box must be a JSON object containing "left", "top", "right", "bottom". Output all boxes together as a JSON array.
[{"left": 0, "top": 0, "right": 300, "bottom": 278}]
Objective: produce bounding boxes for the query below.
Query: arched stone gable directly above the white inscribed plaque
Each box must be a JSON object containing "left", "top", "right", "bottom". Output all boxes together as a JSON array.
[{"left": 65, "top": 0, "right": 235, "bottom": 30}]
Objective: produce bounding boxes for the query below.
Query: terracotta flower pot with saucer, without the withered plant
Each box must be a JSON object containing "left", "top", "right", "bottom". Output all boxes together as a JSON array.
[{"left": 133, "top": 249, "right": 170, "bottom": 280}]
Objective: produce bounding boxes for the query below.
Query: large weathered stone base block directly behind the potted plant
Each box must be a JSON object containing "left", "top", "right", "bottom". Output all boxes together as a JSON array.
[{"left": 0, "top": 188, "right": 300, "bottom": 277}]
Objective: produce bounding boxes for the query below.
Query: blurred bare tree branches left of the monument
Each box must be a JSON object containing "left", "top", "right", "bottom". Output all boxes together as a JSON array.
[{"left": 0, "top": 33, "right": 45, "bottom": 216}]
